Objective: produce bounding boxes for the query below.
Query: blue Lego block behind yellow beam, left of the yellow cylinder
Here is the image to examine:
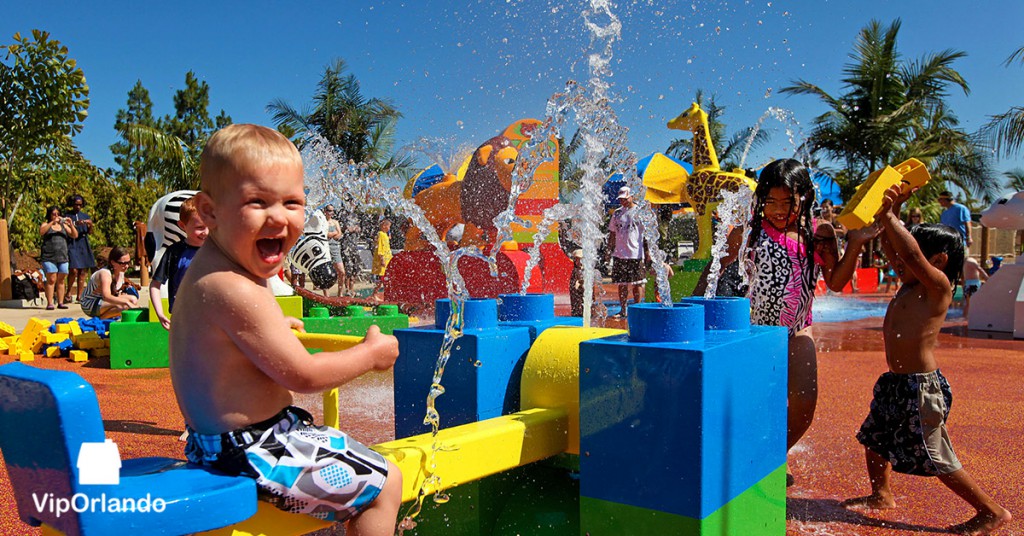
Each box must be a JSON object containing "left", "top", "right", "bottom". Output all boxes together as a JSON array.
[{"left": 394, "top": 299, "right": 530, "bottom": 438}]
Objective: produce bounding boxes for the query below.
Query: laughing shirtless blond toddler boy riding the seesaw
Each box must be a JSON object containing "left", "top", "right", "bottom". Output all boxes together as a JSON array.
[{"left": 170, "top": 124, "right": 401, "bottom": 536}]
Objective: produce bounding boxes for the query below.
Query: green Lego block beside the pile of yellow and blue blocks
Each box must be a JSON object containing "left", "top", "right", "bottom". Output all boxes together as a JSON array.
[{"left": 110, "top": 310, "right": 168, "bottom": 369}]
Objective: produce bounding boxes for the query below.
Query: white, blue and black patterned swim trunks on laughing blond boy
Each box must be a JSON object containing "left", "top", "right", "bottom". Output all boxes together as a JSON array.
[{"left": 185, "top": 406, "right": 387, "bottom": 522}]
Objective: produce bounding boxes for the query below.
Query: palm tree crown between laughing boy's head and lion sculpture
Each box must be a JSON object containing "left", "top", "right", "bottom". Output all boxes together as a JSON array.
[{"left": 266, "top": 58, "right": 414, "bottom": 175}]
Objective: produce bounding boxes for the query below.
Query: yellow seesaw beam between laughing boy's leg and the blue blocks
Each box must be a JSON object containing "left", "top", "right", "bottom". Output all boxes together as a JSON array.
[{"left": 373, "top": 409, "right": 568, "bottom": 502}]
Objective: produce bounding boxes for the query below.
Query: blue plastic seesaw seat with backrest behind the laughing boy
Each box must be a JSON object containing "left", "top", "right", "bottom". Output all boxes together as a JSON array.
[{"left": 0, "top": 363, "right": 256, "bottom": 535}]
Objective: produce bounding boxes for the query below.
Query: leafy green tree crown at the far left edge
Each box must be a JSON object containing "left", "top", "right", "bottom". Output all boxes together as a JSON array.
[{"left": 0, "top": 30, "right": 89, "bottom": 217}]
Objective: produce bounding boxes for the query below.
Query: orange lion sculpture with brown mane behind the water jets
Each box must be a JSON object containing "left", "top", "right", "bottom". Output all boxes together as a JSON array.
[{"left": 406, "top": 119, "right": 557, "bottom": 250}]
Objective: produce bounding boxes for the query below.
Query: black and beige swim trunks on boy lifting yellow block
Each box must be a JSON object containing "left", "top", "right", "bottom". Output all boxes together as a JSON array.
[{"left": 857, "top": 370, "right": 963, "bottom": 477}]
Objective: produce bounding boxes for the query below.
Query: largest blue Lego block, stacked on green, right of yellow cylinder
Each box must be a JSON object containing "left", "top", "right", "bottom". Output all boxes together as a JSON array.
[{"left": 580, "top": 298, "right": 788, "bottom": 530}]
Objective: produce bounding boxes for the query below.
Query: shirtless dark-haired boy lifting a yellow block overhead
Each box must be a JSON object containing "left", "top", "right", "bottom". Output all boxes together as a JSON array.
[{"left": 843, "top": 185, "right": 1013, "bottom": 535}]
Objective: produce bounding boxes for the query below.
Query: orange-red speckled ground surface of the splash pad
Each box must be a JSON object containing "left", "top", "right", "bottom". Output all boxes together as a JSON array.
[{"left": 0, "top": 295, "right": 1024, "bottom": 536}]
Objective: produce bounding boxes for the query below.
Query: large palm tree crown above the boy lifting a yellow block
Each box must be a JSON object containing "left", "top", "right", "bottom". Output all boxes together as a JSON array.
[{"left": 781, "top": 19, "right": 996, "bottom": 199}]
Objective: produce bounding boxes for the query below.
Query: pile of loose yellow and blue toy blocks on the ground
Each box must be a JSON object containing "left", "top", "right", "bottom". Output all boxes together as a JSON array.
[{"left": 0, "top": 318, "right": 111, "bottom": 363}]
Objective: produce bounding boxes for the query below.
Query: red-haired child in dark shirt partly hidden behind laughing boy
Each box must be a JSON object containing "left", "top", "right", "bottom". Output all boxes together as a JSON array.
[{"left": 150, "top": 197, "right": 209, "bottom": 329}]
